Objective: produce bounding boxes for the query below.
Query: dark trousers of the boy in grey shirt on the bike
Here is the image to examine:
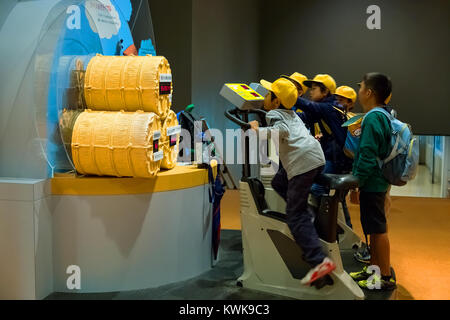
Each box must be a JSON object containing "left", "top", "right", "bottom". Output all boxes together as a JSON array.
[{"left": 272, "top": 167, "right": 326, "bottom": 267}]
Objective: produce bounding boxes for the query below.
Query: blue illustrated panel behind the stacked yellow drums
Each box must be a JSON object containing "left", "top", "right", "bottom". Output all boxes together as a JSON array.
[{"left": 47, "top": 0, "right": 156, "bottom": 176}]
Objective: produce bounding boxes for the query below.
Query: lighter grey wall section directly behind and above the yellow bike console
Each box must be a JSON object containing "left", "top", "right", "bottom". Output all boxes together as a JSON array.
[{"left": 192, "top": 0, "right": 260, "bottom": 181}]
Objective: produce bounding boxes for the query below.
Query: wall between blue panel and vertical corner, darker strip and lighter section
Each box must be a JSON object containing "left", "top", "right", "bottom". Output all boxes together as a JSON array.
[{"left": 149, "top": 0, "right": 261, "bottom": 181}]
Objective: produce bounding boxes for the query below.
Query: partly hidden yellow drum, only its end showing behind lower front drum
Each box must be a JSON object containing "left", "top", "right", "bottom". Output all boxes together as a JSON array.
[{"left": 161, "top": 110, "right": 181, "bottom": 169}]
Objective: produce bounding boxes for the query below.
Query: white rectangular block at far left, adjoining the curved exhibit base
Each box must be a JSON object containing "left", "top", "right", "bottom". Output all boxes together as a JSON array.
[{"left": 0, "top": 178, "right": 53, "bottom": 299}]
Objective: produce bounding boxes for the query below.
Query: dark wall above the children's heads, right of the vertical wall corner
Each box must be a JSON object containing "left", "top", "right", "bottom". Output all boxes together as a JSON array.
[{"left": 259, "top": 0, "right": 450, "bottom": 135}]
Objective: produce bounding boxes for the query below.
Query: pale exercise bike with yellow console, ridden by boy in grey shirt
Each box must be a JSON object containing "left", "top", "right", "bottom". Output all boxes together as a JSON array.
[{"left": 220, "top": 84, "right": 392, "bottom": 300}]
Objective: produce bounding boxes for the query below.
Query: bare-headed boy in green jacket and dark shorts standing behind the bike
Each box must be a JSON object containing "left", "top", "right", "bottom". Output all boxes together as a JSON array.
[{"left": 350, "top": 73, "right": 396, "bottom": 290}]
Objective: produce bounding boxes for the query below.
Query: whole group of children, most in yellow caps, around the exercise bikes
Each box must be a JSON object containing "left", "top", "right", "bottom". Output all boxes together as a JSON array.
[{"left": 250, "top": 73, "right": 396, "bottom": 290}]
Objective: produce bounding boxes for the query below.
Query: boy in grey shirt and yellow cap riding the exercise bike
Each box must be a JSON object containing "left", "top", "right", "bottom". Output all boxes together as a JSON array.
[{"left": 250, "top": 78, "right": 336, "bottom": 285}]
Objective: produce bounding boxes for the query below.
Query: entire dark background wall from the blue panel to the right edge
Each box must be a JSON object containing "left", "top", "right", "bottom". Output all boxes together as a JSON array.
[{"left": 149, "top": 0, "right": 450, "bottom": 139}]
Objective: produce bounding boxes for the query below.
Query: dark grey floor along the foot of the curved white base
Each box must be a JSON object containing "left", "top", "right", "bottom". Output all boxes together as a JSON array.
[{"left": 46, "top": 230, "right": 392, "bottom": 300}]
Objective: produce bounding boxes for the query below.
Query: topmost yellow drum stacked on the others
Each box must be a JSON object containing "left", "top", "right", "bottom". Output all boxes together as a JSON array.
[{"left": 84, "top": 55, "right": 173, "bottom": 119}]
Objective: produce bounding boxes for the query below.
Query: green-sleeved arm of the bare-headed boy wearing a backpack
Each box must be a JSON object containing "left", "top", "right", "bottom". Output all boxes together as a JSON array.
[{"left": 353, "top": 113, "right": 389, "bottom": 187}]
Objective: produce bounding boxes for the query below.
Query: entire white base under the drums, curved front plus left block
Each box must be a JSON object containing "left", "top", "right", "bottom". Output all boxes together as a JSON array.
[{"left": 0, "top": 179, "right": 212, "bottom": 299}]
